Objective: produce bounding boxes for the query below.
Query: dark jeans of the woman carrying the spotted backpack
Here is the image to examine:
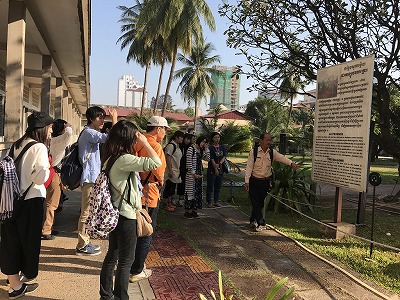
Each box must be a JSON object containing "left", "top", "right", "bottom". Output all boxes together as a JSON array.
[{"left": 100, "top": 215, "right": 137, "bottom": 300}]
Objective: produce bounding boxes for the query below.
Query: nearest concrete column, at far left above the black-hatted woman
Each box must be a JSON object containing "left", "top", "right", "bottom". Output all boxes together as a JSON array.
[{"left": 4, "top": 0, "right": 26, "bottom": 142}]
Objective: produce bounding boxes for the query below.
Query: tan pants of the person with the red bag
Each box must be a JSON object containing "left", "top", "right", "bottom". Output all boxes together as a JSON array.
[{"left": 42, "top": 173, "right": 61, "bottom": 235}]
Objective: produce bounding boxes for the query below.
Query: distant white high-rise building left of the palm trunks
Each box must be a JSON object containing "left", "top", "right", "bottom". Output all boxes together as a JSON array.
[{"left": 117, "top": 75, "right": 147, "bottom": 108}]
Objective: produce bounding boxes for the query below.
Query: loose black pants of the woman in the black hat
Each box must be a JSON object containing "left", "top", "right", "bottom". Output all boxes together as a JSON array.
[{"left": 0, "top": 197, "right": 44, "bottom": 278}]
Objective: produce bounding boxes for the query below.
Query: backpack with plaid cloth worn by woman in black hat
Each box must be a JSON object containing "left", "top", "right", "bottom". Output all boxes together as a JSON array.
[{"left": 0, "top": 141, "right": 38, "bottom": 223}]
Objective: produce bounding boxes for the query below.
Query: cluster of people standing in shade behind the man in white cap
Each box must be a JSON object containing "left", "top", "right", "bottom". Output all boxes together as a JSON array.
[{"left": 162, "top": 130, "right": 227, "bottom": 218}]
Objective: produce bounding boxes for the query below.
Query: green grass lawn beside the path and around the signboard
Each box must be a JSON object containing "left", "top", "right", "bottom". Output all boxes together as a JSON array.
[{"left": 160, "top": 153, "right": 400, "bottom": 295}]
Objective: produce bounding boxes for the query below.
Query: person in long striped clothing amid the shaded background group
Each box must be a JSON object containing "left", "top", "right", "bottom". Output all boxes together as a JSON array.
[{"left": 184, "top": 135, "right": 210, "bottom": 219}]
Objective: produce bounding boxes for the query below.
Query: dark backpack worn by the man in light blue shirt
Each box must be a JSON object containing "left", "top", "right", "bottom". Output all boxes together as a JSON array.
[{"left": 60, "top": 131, "right": 93, "bottom": 190}]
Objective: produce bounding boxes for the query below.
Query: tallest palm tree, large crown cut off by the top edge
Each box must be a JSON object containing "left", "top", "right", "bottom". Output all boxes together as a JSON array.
[{"left": 134, "top": 0, "right": 215, "bottom": 115}]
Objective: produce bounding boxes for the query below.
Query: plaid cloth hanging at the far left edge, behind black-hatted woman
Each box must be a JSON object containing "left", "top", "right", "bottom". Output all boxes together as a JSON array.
[{"left": 0, "top": 156, "right": 21, "bottom": 220}]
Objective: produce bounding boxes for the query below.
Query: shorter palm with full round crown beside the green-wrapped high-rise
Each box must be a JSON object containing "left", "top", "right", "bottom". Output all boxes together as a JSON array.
[{"left": 174, "top": 40, "right": 220, "bottom": 128}]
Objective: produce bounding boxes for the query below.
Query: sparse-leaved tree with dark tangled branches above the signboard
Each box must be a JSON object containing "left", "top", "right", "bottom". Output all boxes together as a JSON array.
[{"left": 219, "top": 0, "right": 400, "bottom": 159}]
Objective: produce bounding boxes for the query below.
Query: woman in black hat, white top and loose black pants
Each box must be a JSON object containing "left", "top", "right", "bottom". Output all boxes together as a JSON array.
[{"left": 0, "top": 112, "right": 54, "bottom": 299}]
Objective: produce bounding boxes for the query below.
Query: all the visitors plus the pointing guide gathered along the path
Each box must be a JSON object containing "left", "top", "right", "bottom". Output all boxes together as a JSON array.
[{"left": 0, "top": 106, "right": 298, "bottom": 300}]
